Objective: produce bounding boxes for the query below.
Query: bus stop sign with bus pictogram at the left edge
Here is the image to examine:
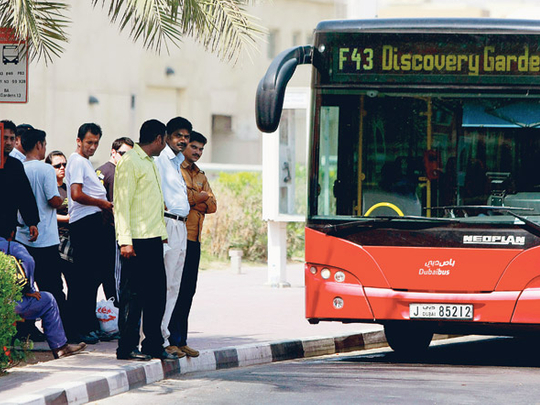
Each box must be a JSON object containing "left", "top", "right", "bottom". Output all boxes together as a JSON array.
[{"left": 0, "top": 28, "right": 28, "bottom": 103}]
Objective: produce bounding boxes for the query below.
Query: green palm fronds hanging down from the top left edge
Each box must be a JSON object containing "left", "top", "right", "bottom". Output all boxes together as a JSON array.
[{"left": 0, "top": 0, "right": 264, "bottom": 63}]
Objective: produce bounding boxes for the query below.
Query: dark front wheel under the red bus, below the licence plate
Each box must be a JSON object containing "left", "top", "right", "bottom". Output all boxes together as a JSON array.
[{"left": 384, "top": 322, "right": 433, "bottom": 354}]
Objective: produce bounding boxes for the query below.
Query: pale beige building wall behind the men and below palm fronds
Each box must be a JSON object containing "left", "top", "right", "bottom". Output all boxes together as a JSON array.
[{"left": 0, "top": 0, "right": 335, "bottom": 166}]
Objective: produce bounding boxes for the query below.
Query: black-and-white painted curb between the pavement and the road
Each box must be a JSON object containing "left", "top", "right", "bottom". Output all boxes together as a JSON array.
[{"left": 0, "top": 331, "right": 386, "bottom": 405}]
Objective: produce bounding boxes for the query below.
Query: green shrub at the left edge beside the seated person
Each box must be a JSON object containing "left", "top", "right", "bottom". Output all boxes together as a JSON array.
[{"left": 0, "top": 252, "right": 25, "bottom": 373}]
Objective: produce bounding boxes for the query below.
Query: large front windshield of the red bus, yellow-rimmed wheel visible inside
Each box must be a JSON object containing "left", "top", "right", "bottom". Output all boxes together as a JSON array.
[{"left": 309, "top": 89, "right": 540, "bottom": 223}]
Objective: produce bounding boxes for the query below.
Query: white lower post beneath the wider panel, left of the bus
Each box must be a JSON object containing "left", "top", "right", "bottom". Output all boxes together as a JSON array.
[{"left": 268, "top": 221, "right": 291, "bottom": 287}]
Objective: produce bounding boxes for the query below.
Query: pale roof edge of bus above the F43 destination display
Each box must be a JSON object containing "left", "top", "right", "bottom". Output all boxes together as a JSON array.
[{"left": 315, "top": 18, "right": 540, "bottom": 34}]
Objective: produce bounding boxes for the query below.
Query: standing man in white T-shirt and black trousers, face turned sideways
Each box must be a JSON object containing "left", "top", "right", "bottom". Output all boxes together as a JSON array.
[{"left": 65, "top": 123, "right": 115, "bottom": 344}]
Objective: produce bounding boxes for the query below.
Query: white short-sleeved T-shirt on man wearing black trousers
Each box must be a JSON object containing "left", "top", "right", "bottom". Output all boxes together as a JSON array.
[{"left": 65, "top": 153, "right": 107, "bottom": 224}]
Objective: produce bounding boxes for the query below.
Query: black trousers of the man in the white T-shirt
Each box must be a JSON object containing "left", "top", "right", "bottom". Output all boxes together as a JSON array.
[{"left": 68, "top": 212, "right": 115, "bottom": 335}]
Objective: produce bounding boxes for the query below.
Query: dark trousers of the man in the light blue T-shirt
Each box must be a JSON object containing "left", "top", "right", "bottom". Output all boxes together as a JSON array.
[{"left": 21, "top": 245, "right": 70, "bottom": 328}]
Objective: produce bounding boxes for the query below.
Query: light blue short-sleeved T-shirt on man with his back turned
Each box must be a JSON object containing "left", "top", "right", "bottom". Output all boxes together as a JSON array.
[{"left": 15, "top": 160, "right": 60, "bottom": 248}]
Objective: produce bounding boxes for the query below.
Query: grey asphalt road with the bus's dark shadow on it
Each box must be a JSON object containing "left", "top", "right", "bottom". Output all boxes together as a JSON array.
[{"left": 90, "top": 338, "right": 540, "bottom": 405}]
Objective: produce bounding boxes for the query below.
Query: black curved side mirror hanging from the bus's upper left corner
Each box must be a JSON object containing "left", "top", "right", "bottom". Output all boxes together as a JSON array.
[{"left": 255, "top": 46, "right": 313, "bottom": 132}]
